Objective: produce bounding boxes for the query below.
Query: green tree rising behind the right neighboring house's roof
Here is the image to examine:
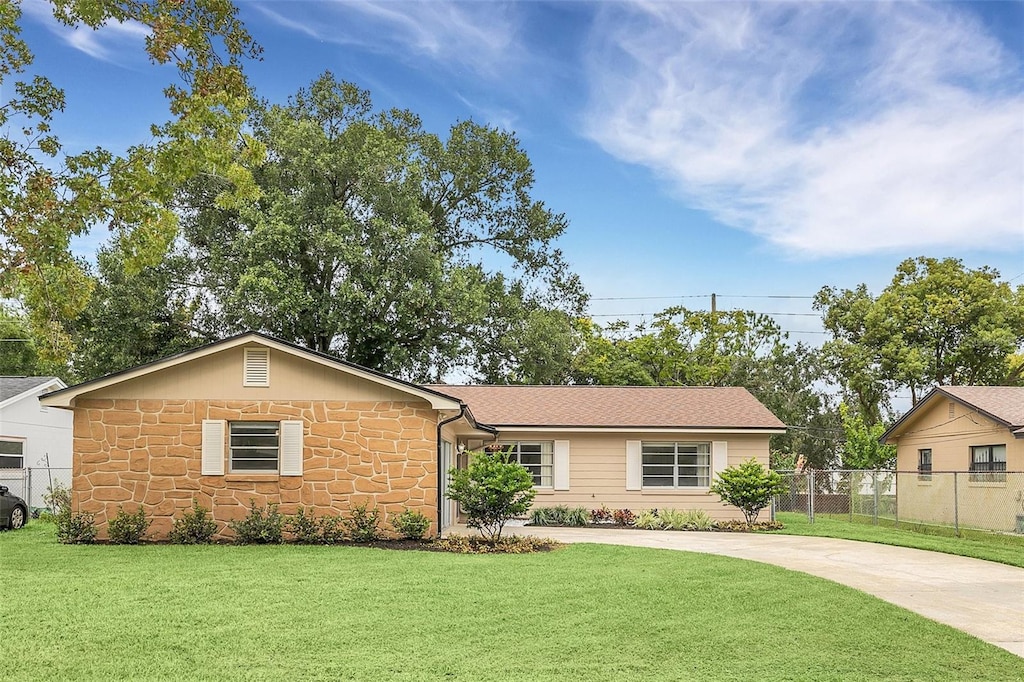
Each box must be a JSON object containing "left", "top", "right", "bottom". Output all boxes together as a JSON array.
[{"left": 815, "top": 257, "right": 1024, "bottom": 425}]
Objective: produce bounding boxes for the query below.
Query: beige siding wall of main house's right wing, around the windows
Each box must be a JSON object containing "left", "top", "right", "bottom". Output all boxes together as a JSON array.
[{"left": 499, "top": 431, "right": 768, "bottom": 520}]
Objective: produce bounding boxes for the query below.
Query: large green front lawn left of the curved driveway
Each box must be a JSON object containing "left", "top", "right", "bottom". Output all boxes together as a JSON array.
[{"left": 0, "top": 522, "right": 1024, "bottom": 681}]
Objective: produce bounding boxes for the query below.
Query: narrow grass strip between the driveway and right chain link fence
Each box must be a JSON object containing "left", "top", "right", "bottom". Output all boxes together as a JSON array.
[{"left": 770, "top": 512, "right": 1024, "bottom": 568}]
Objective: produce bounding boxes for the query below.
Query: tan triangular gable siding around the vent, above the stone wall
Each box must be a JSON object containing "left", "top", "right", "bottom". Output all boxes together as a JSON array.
[{"left": 76, "top": 344, "right": 410, "bottom": 402}]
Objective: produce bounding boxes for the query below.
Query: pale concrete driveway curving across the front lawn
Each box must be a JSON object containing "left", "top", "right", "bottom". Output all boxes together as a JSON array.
[{"left": 468, "top": 526, "right": 1024, "bottom": 657}]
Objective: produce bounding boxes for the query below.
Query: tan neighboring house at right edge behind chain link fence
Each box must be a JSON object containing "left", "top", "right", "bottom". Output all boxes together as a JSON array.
[{"left": 882, "top": 386, "right": 1024, "bottom": 532}]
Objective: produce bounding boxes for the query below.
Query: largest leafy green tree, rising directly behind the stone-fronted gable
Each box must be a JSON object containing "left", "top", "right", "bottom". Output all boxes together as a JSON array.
[{"left": 176, "top": 73, "right": 584, "bottom": 379}]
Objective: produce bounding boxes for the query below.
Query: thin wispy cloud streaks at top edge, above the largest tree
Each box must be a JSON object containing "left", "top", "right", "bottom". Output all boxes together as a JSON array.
[{"left": 256, "top": 0, "right": 523, "bottom": 77}]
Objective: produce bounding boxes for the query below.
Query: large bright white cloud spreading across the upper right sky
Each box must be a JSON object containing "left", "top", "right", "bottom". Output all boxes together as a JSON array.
[{"left": 587, "top": 3, "right": 1024, "bottom": 256}]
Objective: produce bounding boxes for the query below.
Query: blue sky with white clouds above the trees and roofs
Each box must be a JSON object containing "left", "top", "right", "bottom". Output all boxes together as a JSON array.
[{"left": 16, "top": 0, "right": 1024, "bottom": 342}]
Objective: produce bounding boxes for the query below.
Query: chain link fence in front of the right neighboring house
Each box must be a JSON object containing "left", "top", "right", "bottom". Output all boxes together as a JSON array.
[{"left": 772, "top": 470, "right": 1024, "bottom": 535}]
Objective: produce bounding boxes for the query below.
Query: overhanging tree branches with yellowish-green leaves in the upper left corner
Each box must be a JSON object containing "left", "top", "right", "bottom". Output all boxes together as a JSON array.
[{"left": 0, "top": 0, "right": 261, "bottom": 359}]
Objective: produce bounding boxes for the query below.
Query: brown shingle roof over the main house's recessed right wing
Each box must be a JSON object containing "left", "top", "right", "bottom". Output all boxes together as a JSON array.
[{"left": 428, "top": 385, "right": 785, "bottom": 429}]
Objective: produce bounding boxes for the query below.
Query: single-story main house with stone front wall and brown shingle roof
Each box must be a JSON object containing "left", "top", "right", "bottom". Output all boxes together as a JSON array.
[{"left": 41, "top": 333, "right": 784, "bottom": 538}]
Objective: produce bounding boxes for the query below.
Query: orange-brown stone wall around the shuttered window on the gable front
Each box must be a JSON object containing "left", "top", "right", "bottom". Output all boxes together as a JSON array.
[{"left": 72, "top": 399, "right": 437, "bottom": 539}]
